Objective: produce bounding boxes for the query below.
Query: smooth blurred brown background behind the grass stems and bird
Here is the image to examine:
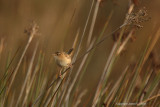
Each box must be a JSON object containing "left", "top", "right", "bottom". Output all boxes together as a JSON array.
[{"left": 0, "top": 0, "right": 160, "bottom": 104}]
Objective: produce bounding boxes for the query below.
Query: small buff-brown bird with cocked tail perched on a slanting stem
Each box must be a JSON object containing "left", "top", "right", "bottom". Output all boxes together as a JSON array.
[{"left": 53, "top": 48, "right": 73, "bottom": 76}]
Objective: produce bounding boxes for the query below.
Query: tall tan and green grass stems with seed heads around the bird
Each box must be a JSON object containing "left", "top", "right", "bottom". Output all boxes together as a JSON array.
[{"left": 0, "top": 0, "right": 160, "bottom": 107}]
